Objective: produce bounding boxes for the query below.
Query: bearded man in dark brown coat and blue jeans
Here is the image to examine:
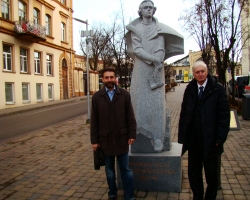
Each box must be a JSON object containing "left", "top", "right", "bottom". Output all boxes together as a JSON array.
[{"left": 90, "top": 68, "right": 136, "bottom": 200}]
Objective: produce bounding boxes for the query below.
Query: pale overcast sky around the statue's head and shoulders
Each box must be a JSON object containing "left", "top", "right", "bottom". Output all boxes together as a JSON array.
[{"left": 73, "top": 0, "right": 199, "bottom": 63}]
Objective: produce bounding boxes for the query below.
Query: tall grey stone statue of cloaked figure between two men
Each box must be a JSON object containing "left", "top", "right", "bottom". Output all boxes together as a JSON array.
[{"left": 126, "top": 0, "right": 184, "bottom": 153}]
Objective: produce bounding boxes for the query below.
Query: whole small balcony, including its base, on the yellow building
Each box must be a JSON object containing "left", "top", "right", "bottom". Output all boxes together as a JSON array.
[{"left": 15, "top": 20, "right": 46, "bottom": 42}]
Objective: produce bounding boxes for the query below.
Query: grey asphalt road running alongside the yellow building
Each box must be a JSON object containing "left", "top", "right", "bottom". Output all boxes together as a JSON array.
[{"left": 0, "top": 100, "right": 88, "bottom": 141}]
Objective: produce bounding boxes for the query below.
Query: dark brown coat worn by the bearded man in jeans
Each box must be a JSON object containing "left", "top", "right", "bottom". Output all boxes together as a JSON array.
[{"left": 90, "top": 87, "right": 136, "bottom": 156}]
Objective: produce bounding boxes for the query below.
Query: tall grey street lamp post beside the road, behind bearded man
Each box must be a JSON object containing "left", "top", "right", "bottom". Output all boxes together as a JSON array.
[{"left": 73, "top": 18, "right": 93, "bottom": 124}]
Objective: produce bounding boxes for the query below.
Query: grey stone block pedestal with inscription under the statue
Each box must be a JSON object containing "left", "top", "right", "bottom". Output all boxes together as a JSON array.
[{"left": 117, "top": 143, "right": 182, "bottom": 192}]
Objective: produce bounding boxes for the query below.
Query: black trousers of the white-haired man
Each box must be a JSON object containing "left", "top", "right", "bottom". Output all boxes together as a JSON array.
[{"left": 188, "top": 146, "right": 218, "bottom": 200}]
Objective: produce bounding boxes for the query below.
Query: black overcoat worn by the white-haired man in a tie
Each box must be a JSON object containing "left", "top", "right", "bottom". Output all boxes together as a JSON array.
[{"left": 178, "top": 75, "right": 230, "bottom": 158}]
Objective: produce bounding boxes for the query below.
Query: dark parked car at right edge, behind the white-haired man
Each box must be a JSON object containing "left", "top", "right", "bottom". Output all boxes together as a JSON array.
[{"left": 228, "top": 76, "right": 249, "bottom": 97}]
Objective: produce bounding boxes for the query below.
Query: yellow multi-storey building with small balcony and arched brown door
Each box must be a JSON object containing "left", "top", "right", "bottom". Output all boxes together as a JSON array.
[{"left": 0, "top": 0, "right": 74, "bottom": 109}]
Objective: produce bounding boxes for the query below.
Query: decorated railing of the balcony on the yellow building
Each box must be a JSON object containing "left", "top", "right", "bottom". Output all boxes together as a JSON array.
[{"left": 15, "top": 20, "right": 46, "bottom": 39}]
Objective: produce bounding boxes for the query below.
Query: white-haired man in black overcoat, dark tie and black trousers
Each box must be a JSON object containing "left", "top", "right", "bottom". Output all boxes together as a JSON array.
[{"left": 178, "top": 61, "right": 230, "bottom": 200}]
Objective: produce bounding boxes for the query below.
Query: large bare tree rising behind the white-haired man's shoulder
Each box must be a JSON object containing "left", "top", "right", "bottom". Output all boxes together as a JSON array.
[{"left": 181, "top": 0, "right": 249, "bottom": 86}]
